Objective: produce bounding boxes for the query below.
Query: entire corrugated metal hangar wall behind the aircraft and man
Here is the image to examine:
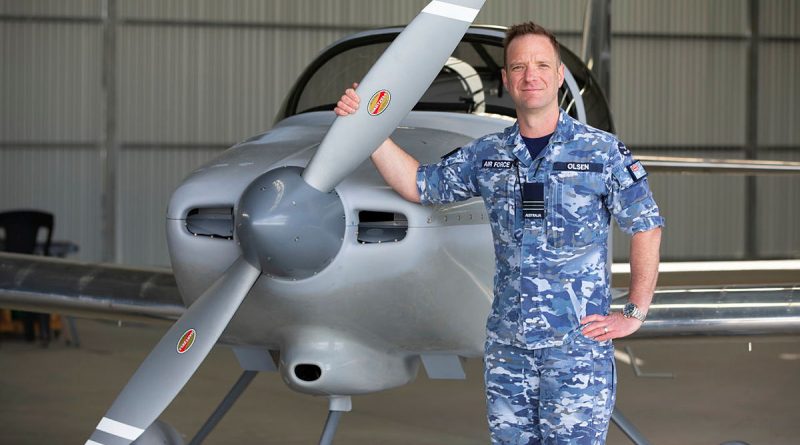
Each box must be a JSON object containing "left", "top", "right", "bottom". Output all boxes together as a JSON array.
[{"left": 0, "top": 0, "right": 800, "bottom": 265}]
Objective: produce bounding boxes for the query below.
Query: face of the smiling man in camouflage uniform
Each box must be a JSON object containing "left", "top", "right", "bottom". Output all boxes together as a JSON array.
[{"left": 502, "top": 34, "right": 564, "bottom": 113}]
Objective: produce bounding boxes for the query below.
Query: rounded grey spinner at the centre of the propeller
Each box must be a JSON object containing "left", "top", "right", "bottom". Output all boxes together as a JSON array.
[{"left": 236, "top": 167, "right": 345, "bottom": 279}]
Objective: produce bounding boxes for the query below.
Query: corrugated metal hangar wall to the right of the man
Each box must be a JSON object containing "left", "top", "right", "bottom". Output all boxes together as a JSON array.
[{"left": 611, "top": 0, "right": 800, "bottom": 259}]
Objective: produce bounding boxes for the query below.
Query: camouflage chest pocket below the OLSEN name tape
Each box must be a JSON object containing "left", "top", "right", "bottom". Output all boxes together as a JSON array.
[{"left": 545, "top": 171, "right": 606, "bottom": 248}]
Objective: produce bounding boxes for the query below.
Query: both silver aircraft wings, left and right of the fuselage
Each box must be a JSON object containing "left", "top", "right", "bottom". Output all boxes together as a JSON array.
[{"left": 0, "top": 253, "right": 800, "bottom": 337}]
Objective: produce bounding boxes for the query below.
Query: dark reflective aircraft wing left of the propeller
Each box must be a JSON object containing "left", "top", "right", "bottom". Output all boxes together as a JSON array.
[{"left": 0, "top": 253, "right": 185, "bottom": 322}]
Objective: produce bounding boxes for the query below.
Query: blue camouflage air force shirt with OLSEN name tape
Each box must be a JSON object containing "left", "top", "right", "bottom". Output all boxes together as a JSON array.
[{"left": 417, "top": 111, "right": 664, "bottom": 349}]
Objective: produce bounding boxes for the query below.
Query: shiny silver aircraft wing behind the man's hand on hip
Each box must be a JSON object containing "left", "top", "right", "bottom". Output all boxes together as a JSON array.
[{"left": 611, "top": 260, "right": 800, "bottom": 337}]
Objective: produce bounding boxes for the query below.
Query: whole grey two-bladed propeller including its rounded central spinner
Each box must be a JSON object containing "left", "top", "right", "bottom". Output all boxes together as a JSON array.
[{"left": 86, "top": 0, "right": 484, "bottom": 445}]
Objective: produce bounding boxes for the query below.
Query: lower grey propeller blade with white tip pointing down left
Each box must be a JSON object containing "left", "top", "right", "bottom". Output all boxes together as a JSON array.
[{"left": 86, "top": 257, "right": 261, "bottom": 445}]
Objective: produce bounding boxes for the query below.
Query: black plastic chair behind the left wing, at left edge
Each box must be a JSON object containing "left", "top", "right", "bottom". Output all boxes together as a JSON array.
[{"left": 0, "top": 210, "right": 53, "bottom": 346}]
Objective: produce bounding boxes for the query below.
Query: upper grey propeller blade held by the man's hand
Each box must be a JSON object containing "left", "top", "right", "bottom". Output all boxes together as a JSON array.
[{"left": 303, "top": 0, "right": 484, "bottom": 193}]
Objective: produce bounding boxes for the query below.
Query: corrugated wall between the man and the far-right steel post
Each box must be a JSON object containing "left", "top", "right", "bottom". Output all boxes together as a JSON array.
[{"left": 611, "top": 0, "right": 752, "bottom": 260}]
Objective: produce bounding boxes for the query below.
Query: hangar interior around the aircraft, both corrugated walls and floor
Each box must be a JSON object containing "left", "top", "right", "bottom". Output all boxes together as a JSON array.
[{"left": 0, "top": 0, "right": 800, "bottom": 445}]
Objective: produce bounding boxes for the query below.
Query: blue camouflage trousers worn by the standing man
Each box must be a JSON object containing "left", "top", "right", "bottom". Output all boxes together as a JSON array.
[{"left": 484, "top": 336, "right": 617, "bottom": 445}]
